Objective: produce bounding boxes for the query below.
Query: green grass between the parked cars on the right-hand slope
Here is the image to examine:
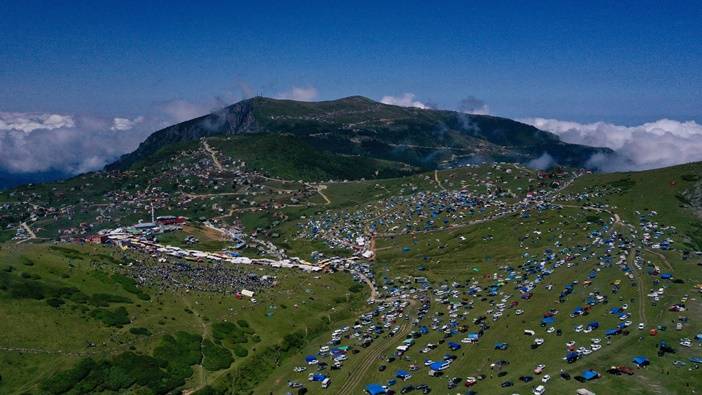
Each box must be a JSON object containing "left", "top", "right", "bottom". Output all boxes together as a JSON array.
[{"left": 260, "top": 164, "right": 702, "bottom": 394}]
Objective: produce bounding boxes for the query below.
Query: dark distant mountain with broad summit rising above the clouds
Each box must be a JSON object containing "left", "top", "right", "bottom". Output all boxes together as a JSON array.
[{"left": 107, "top": 96, "right": 611, "bottom": 170}]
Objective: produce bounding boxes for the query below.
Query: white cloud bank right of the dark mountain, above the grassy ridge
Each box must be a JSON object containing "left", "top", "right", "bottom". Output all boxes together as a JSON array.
[{"left": 520, "top": 118, "right": 702, "bottom": 171}]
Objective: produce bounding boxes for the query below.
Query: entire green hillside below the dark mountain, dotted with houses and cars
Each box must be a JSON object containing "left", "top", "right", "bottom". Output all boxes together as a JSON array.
[{"left": 0, "top": 137, "right": 702, "bottom": 395}]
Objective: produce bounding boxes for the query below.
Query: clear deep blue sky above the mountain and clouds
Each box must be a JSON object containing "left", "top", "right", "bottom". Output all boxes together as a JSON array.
[{"left": 0, "top": 1, "right": 702, "bottom": 124}]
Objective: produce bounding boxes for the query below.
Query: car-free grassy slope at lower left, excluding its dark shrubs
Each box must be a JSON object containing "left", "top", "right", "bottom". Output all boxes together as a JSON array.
[{"left": 0, "top": 245, "right": 372, "bottom": 394}]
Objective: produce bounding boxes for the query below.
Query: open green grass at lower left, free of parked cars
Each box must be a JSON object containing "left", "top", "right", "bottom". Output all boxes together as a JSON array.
[{"left": 0, "top": 244, "right": 372, "bottom": 394}]
